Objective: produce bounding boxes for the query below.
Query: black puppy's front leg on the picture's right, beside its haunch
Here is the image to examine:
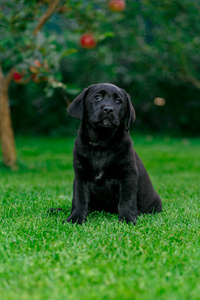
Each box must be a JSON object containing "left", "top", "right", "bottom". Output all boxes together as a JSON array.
[{"left": 118, "top": 178, "right": 137, "bottom": 225}]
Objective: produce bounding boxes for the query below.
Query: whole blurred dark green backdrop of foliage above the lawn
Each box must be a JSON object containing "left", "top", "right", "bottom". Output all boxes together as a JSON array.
[{"left": 0, "top": 0, "right": 200, "bottom": 136}]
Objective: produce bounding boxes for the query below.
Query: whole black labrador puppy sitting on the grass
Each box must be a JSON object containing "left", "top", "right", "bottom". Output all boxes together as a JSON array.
[{"left": 49, "top": 83, "right": 162, "bottom": 224}]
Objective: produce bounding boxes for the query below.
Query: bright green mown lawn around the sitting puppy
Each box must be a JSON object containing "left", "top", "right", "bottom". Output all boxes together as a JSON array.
[{"left": 0, "top": 136, "right": 200, "bottom": 300}]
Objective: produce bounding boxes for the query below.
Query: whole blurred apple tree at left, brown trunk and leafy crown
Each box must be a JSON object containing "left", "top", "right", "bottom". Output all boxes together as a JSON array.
[{"left": 0, "top": 0, "right": 115, "bottom": 168}]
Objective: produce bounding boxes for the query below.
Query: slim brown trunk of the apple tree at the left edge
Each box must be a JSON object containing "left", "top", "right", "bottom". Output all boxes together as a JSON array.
[{"left": 0, "top": 68, "right": 17, "bottom": 170}]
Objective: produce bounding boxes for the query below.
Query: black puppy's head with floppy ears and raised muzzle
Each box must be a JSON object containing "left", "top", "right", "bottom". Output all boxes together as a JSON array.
[{"left": 68, "top": 83, "right": 135, "bottom": 130}]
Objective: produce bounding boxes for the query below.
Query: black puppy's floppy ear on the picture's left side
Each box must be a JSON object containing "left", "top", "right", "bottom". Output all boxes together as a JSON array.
[{"left": 68, "top": 88, "right": 88, "bottom": 120}]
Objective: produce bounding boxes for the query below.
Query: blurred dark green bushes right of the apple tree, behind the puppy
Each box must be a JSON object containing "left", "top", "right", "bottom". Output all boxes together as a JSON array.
[{"left": 63, "top": 0, "right": 200, "bottom": 134}]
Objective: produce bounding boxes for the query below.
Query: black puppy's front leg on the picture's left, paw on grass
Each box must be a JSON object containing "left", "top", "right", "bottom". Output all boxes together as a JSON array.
[{"left": 65, "top": 177, "right": 89, "bottom": 224}]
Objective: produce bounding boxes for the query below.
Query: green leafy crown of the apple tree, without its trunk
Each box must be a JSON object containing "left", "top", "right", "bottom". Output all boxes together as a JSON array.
[{"left": 0, "top": 0, "right": 114, "bottom": 97}]
